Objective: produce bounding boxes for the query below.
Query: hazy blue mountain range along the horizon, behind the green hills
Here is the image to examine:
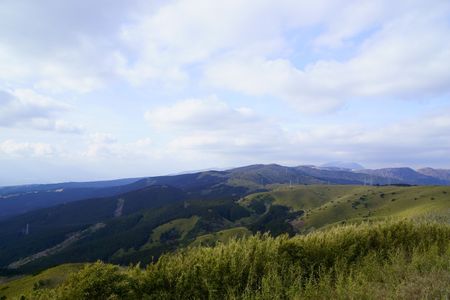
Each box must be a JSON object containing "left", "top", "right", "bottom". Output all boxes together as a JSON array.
[{"left": 0, "top": 162, "right": 450, "bottom": 219}]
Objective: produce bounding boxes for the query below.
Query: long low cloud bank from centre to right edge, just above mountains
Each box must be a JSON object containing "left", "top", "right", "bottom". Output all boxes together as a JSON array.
[{"left": 143, "top": 98, "right": 450, "bottom": 166}]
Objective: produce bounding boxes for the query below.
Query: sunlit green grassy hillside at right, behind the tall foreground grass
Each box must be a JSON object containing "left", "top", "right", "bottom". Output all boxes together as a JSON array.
[{"left": 242, "top": 185, "right": 450, "bottom": 231}]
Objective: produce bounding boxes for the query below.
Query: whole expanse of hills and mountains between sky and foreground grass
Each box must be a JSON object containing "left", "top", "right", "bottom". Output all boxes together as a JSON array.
[{"left": 0, "top": 164, "right": 450, "bottom": 275}]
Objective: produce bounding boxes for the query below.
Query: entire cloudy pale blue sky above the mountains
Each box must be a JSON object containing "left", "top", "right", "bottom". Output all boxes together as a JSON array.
[{"left": 0, "top": 0, "right": 450, "bottom": 185}]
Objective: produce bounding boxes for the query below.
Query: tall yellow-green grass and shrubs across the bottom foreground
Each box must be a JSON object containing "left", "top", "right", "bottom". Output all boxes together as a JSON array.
[{"left": 6, "top": 221, "right": 450, "bottom": 299}]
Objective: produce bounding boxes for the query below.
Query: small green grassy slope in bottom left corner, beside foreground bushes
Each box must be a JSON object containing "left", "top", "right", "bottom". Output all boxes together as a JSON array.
[{"left": 0, "top": 264, "right": 84, "bottom": 299}]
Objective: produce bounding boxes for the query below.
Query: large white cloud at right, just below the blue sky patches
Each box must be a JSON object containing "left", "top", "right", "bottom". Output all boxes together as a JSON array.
[{"left": 206, "top": 6, "right": 450, "bottom": 112}]
